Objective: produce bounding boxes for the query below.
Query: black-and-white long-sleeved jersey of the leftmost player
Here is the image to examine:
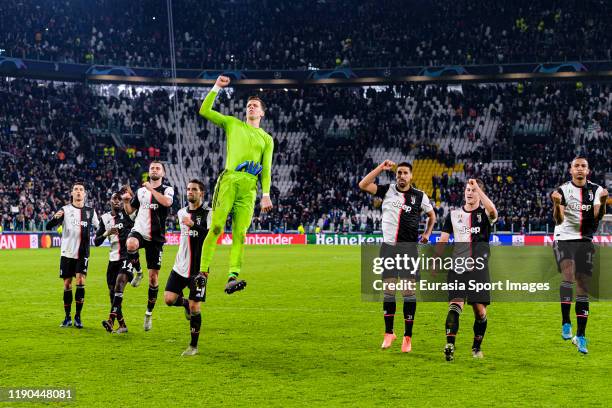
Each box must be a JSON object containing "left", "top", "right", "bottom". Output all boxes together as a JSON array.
[{"left": 47, "top": 204, "right": 100, "bottom": 259}]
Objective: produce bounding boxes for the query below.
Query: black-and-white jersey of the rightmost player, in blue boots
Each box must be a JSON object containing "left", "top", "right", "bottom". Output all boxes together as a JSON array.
[{"left": 555, "top": 181, "right": 603, "bottom": 241}]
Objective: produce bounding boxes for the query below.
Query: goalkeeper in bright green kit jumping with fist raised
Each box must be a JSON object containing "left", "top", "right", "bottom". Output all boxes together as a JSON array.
[{"left": 197, "top": 76, "right": 274, "bottom": 294}]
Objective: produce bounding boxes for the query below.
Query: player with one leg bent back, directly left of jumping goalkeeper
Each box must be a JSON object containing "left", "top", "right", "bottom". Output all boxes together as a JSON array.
[{"left": 164, "top": 179, "right": 211, "bottom": 356}]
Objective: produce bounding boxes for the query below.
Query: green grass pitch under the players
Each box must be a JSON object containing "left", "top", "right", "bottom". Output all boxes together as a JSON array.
[{"left": 0, "top": 246, "right": 612, "bottom": 407}]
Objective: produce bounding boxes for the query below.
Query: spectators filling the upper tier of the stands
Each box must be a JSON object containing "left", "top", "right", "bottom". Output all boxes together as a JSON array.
[{"left": 0, "top": 0, "right": 612, "bottom": 69}]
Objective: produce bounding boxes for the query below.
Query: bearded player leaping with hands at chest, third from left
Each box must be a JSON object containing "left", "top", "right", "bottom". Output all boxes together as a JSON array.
[{"left": 121, "top": 161, "right": 174, "bottom": 331}]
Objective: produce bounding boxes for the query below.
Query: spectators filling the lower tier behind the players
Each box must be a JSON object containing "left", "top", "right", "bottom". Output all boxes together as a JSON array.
[{"left": 0, "top": 80, "right": 612, "bottom": 232}]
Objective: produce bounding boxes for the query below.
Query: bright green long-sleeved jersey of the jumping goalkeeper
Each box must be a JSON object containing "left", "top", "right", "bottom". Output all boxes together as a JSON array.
[{"left": 200, "top": 91, "right": 274, "bottom": 194}]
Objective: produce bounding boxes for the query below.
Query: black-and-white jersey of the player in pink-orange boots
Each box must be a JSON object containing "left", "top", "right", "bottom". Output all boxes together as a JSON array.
[{"left": 376, "top": 184, "right": 433, "bottom": 244}]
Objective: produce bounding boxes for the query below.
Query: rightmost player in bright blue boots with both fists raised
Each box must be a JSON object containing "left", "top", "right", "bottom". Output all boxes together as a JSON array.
[{"left": 551, "top": 156, "right": 608, "bottom": 354}]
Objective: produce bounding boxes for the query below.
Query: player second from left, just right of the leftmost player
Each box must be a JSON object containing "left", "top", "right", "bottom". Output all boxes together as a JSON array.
[{"left": 94, "top": 191, "right": 136, "bottom": 333}]
